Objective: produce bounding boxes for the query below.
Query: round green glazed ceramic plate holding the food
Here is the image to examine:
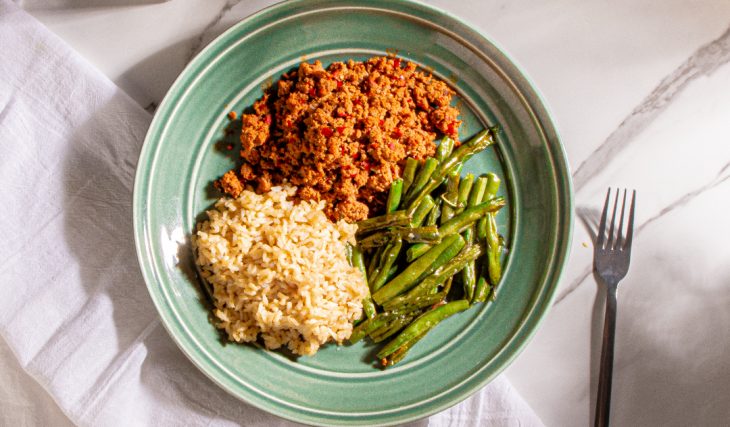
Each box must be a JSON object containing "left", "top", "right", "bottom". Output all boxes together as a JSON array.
[{"left": 134, "top": 0, "right": 572, "bottom": 425}]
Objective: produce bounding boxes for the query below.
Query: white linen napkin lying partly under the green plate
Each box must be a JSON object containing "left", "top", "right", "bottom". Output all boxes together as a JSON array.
[{"left": 0, "top": 0, "right": 542, "bottom": 426}]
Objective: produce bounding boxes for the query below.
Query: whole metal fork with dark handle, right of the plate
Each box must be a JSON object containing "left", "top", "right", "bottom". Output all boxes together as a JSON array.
[{"left": 593, "top": 188, "right": 636, "bottom": 427}]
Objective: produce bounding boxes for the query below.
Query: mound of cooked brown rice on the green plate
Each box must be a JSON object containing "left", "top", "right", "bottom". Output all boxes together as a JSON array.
[{"left": 193, "top": 186, "right": 367, "bottom": 355}]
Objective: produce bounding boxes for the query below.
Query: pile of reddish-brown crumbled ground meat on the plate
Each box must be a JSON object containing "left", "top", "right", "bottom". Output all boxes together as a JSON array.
[{"left": 216, "top": 57, "right": 461, "bottom": 222}]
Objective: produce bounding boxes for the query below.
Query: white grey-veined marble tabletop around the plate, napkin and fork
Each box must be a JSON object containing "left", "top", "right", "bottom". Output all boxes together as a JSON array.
[{"left": 8, "top": 0, "right": 730, "bottom": 426}]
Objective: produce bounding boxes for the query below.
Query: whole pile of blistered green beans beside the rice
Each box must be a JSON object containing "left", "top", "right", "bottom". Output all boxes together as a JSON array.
[{"left": 348, "top": 128, "right": 505, "bottom": 367}]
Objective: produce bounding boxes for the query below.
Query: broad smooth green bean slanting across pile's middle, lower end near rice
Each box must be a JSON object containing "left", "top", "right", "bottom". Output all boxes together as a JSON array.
[{"left": 373, "top": 234, "right": 464, "bottom": 305}]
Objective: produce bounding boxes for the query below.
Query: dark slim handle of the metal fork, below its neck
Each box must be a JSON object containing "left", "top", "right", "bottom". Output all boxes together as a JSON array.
[{"left": 595, "top": 283, "right": 616, "bottom": 427}]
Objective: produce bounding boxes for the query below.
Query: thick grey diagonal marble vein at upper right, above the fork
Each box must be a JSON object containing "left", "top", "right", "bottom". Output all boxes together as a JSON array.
[{"left": 573, "top": 23, "right": 730, "bottom": 193}]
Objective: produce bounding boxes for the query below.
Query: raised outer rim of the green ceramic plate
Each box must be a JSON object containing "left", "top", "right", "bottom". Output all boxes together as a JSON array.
[{"left": 132, "top": 0, "right": 575, "bottom": 425}]
